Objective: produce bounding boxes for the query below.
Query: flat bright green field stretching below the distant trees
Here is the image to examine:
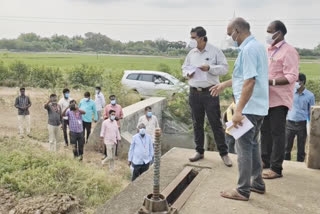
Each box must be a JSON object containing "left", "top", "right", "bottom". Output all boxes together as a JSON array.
[{"left": 0, "top": 53, "right": 320, "bottom": 79}]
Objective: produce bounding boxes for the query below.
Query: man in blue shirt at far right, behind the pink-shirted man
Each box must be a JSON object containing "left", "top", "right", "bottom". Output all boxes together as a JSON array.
[{"left": 285, "top": 73, "right": 315, "bottom": 162}]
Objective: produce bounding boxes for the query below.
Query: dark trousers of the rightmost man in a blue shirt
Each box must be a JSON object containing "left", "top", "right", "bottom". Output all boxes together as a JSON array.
[{"left": 285, "top": 121, "right": 307, "bottom": 162}]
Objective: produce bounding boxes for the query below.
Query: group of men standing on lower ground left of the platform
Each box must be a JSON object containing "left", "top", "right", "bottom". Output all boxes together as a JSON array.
[{"left": 15, "top": 87, "right": 159, "bottom": 180}]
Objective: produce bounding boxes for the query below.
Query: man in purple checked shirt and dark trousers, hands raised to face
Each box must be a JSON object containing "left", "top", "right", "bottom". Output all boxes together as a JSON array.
[{"left": 62, "top": 100, "right": 86, "bottom": 161}]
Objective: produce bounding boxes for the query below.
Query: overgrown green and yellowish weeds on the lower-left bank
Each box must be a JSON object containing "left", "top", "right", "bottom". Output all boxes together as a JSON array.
[{"left": 0, "top": 139, "right": 129, "bottom": 211}]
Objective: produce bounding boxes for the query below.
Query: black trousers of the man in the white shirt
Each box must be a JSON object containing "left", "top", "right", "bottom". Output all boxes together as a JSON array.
[{"left": 189, "top": 89, "right": 228, "bottom": 156}]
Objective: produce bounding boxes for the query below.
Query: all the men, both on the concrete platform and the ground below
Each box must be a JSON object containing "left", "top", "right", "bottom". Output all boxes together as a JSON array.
[{"left": 15, "top": 18, "right": 315, "bottom": 190}]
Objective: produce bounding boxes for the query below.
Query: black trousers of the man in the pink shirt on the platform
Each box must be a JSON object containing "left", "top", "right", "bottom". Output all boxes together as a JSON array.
[{"left": 261, "top": 106, "right": 288, "bottom": 175}]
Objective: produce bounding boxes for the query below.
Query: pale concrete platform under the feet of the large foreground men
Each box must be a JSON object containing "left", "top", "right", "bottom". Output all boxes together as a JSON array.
[{"left": 96, "top": 148, "right": 320, "bottom": 214}]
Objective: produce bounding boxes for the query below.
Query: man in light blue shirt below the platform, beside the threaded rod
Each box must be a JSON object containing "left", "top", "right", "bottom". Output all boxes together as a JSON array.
[{"left": 128, "top": 123, "right": 154, "bottom": 181}]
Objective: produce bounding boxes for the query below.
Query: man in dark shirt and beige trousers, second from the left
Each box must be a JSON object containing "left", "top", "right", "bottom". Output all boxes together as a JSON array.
[{"left": 44, "top": 94, "right": 62, "bottom": 152}]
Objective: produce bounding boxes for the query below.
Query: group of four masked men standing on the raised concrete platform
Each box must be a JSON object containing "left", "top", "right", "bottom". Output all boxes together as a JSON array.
[{"left": 182, "top": 18, "right": 315, "bottom": 201}]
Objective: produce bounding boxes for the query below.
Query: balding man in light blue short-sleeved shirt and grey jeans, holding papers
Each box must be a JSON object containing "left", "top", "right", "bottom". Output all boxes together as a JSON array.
[{"left": 210, "top": 18, "right": 269, "bottom": 201}]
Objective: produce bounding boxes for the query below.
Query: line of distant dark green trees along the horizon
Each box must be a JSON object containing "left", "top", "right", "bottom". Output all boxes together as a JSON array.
[{"left": 0, "top": 32, "right": 320, "bottom": 57}]
